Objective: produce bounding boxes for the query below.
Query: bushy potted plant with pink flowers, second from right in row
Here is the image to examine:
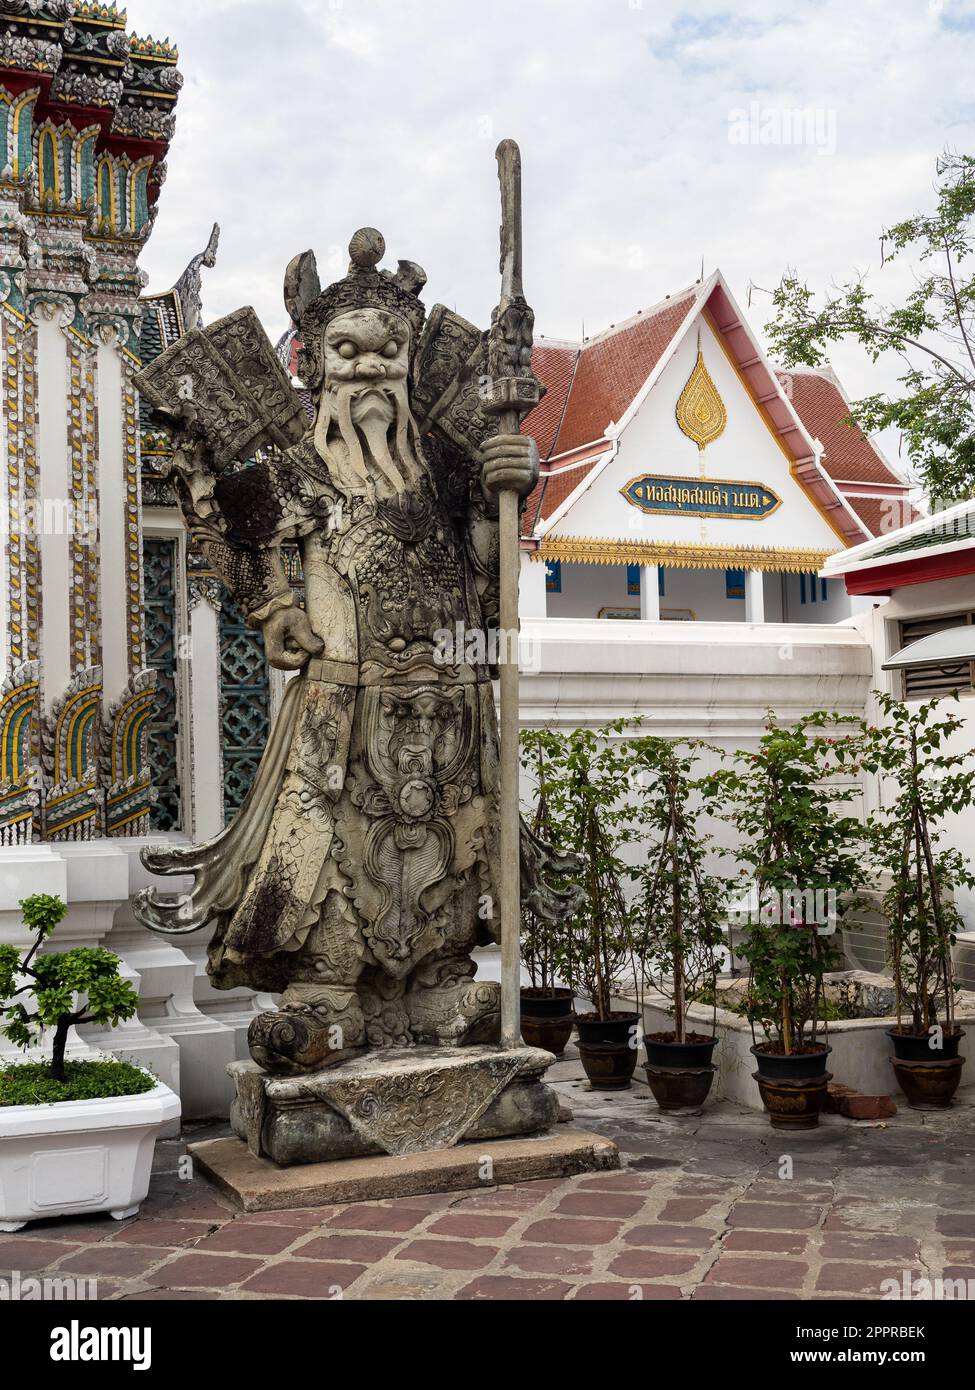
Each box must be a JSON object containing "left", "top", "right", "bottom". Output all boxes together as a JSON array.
[{"left": 705, "top": 713, "right": 864, "bottom": 1129}]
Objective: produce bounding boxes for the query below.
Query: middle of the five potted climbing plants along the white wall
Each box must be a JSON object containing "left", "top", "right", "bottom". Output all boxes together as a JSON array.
[{"left": 630, "top": 735, "right": 726, "bottom": 1111}]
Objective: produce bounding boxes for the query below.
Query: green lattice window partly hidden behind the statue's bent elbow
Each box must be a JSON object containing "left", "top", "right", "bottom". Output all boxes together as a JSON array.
[{"left": 220, "top": 594, "right": 271, "bottom": 821}]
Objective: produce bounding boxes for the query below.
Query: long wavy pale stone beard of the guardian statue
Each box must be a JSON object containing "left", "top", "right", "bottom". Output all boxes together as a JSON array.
[{"left": 314, "top": 378, "right": 421, "bottom": 496}]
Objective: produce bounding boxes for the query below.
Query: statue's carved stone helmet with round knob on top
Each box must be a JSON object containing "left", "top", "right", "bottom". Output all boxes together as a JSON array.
[{"left": 284, "top": 227, "right": 427, "bottom": 389}]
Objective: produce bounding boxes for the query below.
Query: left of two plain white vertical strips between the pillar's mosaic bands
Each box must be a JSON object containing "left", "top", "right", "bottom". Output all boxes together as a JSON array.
[{"left": 36, "top": 304, "right": 72, "bottom": 712}]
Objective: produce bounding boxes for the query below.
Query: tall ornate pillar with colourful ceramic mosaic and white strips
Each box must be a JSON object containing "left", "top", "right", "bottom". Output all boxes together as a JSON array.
[{"left": 0, "top": 0, "right": 182, "bottom": 845}]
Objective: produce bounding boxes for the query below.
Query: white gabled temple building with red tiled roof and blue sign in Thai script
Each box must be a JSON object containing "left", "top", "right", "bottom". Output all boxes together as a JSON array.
[{"left": 522, "top": 271, "right": 912, "bottom": 623}]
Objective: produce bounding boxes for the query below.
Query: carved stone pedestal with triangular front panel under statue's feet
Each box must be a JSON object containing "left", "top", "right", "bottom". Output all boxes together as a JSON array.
[{"left": 228, "top": 1047, "right": 559, "bottom": 1168}]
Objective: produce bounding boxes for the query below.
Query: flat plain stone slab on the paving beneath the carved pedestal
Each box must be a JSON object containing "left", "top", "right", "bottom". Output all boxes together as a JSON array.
[{"left": 188, "top": 1129, "right": 619, "bottom": 1212}]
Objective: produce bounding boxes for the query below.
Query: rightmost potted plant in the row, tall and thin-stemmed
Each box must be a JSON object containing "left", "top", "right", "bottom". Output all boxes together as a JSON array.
[{"left": 865, "top": 694, "right": 975, "bottom": 1109}]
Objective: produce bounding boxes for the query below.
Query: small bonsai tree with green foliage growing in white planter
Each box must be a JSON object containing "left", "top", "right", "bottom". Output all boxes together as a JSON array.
[{"left": 0, "top": 894, "right": 142, "bottom": 1105}]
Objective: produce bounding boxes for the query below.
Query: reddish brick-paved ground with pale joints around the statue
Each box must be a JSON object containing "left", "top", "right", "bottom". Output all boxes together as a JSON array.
[{"left": 0, "top": 1059, "right": 975, "bottom": 1300}]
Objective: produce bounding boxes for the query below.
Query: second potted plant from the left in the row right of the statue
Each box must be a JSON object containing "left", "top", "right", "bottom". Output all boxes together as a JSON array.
[{"left": 540, "top": 721, "right": 640, "bottom": 1090}]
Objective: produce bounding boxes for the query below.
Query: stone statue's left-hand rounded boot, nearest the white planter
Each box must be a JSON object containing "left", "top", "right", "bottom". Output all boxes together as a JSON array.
[{"left": 248, "top": 986, "right": 364, "bottom": 1076}]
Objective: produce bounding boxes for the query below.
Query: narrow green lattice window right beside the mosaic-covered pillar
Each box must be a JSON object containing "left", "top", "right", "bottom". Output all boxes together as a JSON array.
[{"left": 142, "top": 535, "right": 182, "bottom": 830}]
